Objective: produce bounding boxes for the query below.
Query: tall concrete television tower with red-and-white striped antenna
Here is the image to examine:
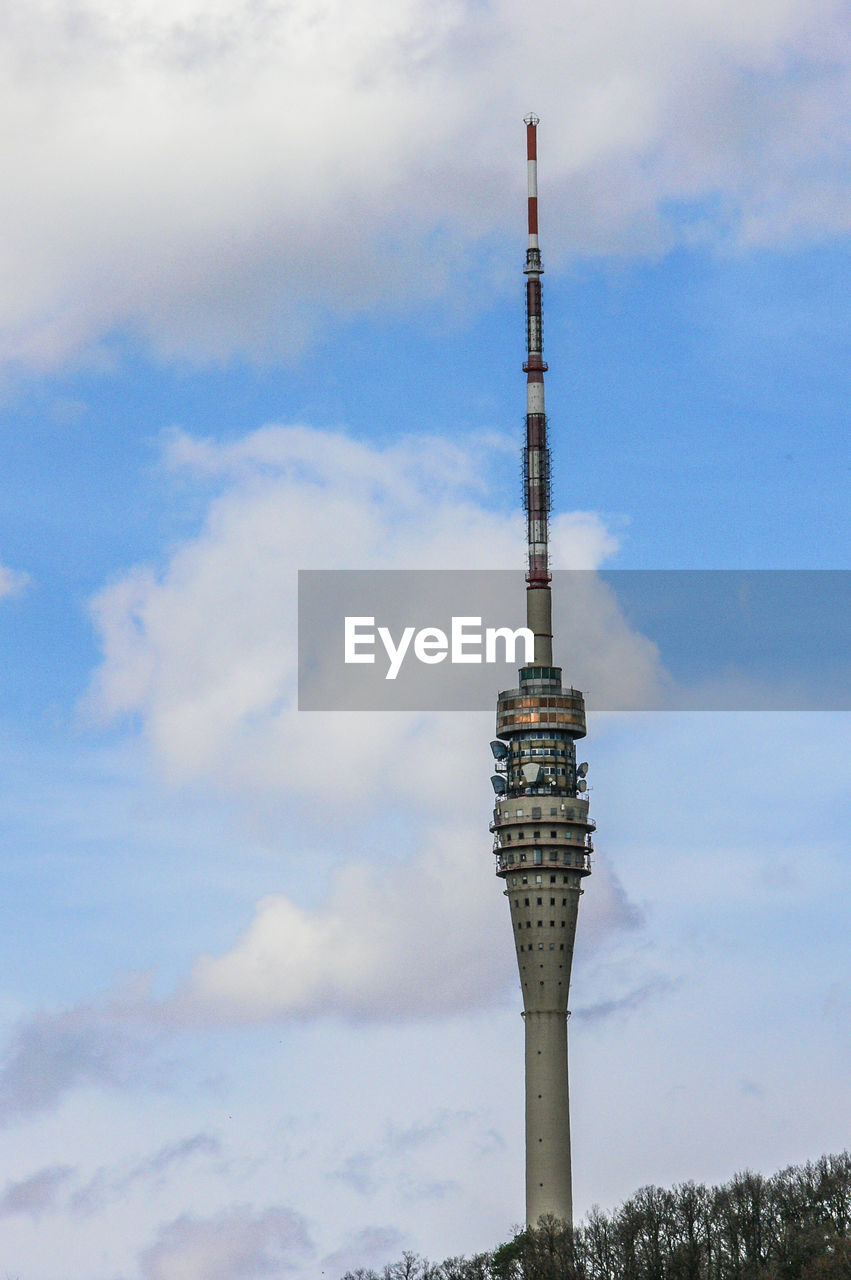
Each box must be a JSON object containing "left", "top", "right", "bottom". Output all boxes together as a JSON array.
[{"left": 490, "top": 115, "right": 594, "bottom": 1224}]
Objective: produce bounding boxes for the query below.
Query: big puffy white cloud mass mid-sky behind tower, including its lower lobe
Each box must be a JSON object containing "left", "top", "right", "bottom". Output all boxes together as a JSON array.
[{"left": 81, "top": 428, "right": 650, "bottom": 1020}]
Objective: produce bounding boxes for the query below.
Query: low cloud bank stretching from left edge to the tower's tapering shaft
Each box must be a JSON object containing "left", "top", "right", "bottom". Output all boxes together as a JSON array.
[{"left": 0, "top": 849, "right": 637, "bottom": 1131}]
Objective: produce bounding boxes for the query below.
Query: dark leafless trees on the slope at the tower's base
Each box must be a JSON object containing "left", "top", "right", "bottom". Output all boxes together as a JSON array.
[{"left": 342, "top": 1151, "right": 851, "bottom": 1280}]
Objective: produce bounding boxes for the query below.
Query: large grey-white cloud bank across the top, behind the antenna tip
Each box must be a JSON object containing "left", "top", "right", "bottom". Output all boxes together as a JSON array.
[{"left": 0, "top": 0, "right": 851, "bottom": 366}]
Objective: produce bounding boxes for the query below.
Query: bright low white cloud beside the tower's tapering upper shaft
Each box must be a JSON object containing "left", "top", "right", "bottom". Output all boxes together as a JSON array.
[{"left": 179, "top": 827, "right": 641, "bottom": 1020}]
